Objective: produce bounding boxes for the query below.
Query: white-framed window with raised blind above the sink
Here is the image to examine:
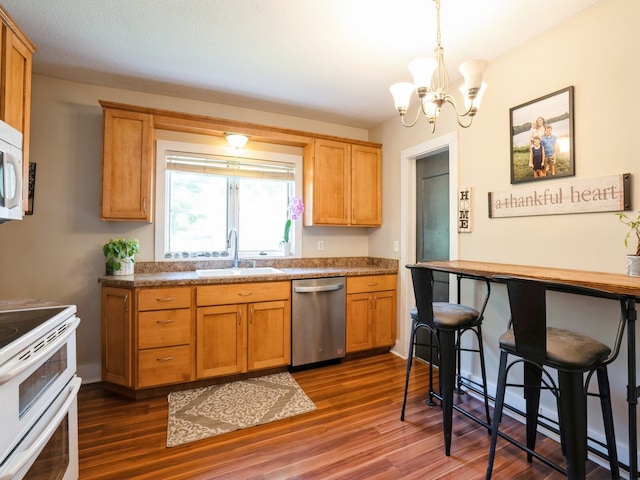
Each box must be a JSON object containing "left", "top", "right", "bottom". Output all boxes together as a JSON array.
[{"left": 156, "top": 140, "right": 302, "bottom": 260}]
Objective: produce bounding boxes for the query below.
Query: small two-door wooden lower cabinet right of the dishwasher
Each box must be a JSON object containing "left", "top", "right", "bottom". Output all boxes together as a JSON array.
[{"left": 346, "top": 275, "right": 397, "bottom": 353}]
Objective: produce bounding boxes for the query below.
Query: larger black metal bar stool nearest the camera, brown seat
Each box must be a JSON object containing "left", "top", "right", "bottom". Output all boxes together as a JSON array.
[{"left": 486, "top": 277, "right": 625, "bottom": 480}]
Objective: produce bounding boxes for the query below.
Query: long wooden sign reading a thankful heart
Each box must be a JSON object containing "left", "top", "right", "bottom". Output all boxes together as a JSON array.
[{"left": 489, "top": 173, "right": 631, "bottom": 218}]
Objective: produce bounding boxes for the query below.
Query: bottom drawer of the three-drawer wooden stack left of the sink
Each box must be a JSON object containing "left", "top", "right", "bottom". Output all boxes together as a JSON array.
[{"left": 137, "top": 345, "right": 193, "bottom": 388}]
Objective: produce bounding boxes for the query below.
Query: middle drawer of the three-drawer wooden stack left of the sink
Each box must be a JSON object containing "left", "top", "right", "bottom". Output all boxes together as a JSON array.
[{"left": 138, "top": 308, "right": 191, "bottom": 348}]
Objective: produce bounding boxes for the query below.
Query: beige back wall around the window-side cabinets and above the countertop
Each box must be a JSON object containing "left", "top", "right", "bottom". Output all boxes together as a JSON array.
[{"left": 0, "top": 75, "right": 376, "bottom": 382}]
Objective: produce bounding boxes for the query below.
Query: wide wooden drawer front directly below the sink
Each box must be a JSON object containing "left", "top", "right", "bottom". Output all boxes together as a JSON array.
[{"left": 196, "top": 282, "right": 291, "bottom": 307}]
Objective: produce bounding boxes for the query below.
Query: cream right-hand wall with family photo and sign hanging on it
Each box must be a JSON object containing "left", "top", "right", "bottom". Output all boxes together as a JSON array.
[{"left": 369, "top": 0, "right": 640, "bottom": 468}]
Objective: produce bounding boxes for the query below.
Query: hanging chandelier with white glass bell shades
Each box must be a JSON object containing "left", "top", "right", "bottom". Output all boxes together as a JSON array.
[{"left": 389, "top": 0, "right": 487, "bottom": 133}]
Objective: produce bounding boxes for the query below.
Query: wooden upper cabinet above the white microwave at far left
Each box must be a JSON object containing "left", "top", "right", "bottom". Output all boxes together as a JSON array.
[{"left": 0, "top": 6, "right": 36, "bottom": 208}]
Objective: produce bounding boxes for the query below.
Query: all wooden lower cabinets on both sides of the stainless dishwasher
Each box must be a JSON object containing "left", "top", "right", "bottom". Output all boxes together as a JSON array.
[{"left": 102, "top": 275, "right": 396, "bottom": 392}]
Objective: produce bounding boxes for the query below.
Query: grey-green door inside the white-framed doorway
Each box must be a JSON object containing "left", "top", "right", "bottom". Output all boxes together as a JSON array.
[{"left": 416, "top": 148, "right": 450, "bottom": 359}]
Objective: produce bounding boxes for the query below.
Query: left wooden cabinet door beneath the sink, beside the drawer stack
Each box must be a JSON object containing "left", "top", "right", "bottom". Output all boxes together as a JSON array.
[{"left": 196, "top": 305, "right": 247, "bottom": 378}]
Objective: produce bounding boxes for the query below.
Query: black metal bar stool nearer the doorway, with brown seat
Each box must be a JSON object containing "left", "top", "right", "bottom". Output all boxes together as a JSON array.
[{"left": 400, "top": 264, "right": 491, "bottom": 456}]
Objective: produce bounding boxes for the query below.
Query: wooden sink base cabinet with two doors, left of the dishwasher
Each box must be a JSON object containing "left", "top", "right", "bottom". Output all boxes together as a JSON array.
[{"left": 196, "top": 282, "right": 291, "bottom": 378}]
